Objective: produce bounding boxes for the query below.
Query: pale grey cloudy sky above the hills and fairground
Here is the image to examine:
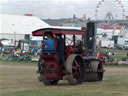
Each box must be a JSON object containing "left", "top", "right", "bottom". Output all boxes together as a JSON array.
[{"left": 0, "top": 0, "right": 128, "bottom": 19}]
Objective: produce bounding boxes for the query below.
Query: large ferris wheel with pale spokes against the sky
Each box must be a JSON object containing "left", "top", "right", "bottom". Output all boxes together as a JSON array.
[{"left": 95, "top": 0, "right": 125, "bottom": 22}]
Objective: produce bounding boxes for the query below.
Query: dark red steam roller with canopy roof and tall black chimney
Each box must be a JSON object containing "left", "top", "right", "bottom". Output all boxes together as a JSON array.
[{"left": 32, "top": 22, "right": 104, "bottom": 85}]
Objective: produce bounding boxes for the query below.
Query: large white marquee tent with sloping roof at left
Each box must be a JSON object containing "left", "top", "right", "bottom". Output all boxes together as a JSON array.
[{"left": 0, "top": 14, "right": 50, "bottom": 40}]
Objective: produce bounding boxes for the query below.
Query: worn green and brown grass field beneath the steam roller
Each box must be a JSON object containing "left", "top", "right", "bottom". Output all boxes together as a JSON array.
[{"left": 0, "top": 61, "right": 128, "bottom": 96}]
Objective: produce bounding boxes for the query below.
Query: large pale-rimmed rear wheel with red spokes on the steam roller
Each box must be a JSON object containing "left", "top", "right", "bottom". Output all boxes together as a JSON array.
[{"left": 66, "top": 54, "right": 85, "bottom": 85}]
